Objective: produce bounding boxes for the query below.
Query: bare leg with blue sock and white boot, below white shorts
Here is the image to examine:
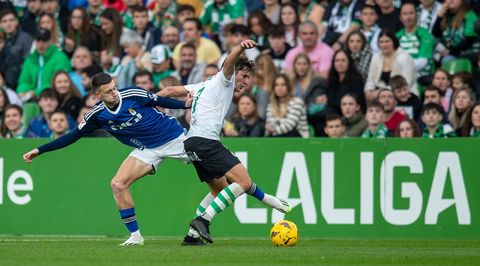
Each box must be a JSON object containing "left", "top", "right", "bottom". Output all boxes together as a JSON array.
[{"left": 111, "top": 156, "right": 153, "bottom": 245}]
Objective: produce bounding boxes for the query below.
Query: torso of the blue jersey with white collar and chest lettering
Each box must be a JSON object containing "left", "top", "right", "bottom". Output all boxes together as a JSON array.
[{"left": 85, "top": 87, "right": 184, "bottom": 149}]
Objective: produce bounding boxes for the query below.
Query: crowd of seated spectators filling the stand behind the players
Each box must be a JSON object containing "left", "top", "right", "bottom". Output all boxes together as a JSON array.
[{"left": 0, "top": 0, "right": 480, "bottom": 138}]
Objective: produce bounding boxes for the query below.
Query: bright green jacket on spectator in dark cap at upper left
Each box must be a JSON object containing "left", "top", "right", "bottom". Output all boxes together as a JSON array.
[{"left": 17, "top": 44, "right": 72, "bottom": 96}]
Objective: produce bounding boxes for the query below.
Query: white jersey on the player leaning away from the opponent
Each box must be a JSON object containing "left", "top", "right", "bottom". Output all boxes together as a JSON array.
[{"left": 185, "top": 71, "right": 235, "bottom": 140}]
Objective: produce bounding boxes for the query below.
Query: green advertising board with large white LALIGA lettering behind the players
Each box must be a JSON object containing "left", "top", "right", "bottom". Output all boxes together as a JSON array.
[{"left": 0, "top": 139, "right": 480, "bottom": 239}]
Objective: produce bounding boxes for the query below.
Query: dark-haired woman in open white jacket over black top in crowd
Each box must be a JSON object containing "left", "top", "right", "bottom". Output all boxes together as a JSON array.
[{"left": 365, "top": 29, "right": 418, "bottom": 101}]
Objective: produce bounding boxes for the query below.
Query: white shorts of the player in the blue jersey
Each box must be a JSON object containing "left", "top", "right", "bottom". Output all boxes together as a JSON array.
[{"left": 128, "top": 133, "right": 191, "bottom": 173}]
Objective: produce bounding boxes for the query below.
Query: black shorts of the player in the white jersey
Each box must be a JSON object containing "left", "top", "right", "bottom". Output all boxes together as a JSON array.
[{"left": 183, "top": 137, "right": 241, "bottom": 183}]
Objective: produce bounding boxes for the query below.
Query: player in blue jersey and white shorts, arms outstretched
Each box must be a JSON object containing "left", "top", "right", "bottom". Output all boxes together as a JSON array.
[{"left": 23, "top": 73, "right": 191, "bottom": 246}]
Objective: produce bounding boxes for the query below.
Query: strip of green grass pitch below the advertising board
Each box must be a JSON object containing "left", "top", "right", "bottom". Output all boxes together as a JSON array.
[{"left": 0, "top": 236, "right": 480, "bottom": 266}]
